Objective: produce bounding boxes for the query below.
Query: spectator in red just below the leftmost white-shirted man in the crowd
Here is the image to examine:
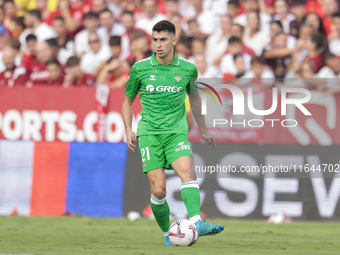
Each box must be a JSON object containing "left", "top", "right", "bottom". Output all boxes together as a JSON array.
[{"left": 23, "top": 42, "right": 53, "bottom": 87}]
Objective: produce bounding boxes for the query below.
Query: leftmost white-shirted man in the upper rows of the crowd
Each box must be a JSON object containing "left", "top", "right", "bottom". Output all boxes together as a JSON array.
[{"left": 25, "top": 9, "right": 56, "bottom": 42}]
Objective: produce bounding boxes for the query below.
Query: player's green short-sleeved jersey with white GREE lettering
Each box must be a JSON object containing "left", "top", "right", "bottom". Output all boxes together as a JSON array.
[{"left": 125, "top": 53, "right": 198, "bottom": 136}]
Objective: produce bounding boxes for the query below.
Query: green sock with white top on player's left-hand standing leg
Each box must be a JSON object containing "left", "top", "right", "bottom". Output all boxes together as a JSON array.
[{"left": 150, "top": 195, "right": 170, "bottom": 232}]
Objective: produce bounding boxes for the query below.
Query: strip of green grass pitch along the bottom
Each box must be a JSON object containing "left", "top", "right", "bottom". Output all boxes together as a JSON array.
[{"left": 0, "top": 216, "right": 340, "bottom": 255}]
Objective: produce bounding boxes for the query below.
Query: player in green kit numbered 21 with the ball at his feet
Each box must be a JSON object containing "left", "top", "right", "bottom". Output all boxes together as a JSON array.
[{"left": 122, "top": 20, "right": 224, "bottom": 246}]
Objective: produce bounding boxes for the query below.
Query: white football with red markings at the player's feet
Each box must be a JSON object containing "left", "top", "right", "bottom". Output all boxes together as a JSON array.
[{"left": 169, "top": 219, "right": 198, "bottom": 246}]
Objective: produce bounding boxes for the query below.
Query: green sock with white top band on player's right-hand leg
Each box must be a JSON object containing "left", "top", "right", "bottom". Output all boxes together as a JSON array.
[{"left": 181, "top": 180, "right": 201, "bottom": 222}]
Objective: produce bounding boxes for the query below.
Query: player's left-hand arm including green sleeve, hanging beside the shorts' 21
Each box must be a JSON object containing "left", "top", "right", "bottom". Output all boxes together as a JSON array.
[{"left": 122, "top": 65, "right": 140, "bottom": 151}]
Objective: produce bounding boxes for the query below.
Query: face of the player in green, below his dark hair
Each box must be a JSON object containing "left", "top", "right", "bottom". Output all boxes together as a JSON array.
[{"left": 152, "top": 31, "right": 177, "bottom": 58}]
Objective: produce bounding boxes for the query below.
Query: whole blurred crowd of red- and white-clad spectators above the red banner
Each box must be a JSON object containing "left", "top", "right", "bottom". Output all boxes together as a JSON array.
[{"left": 0, "top": 0, "right": 340, "bottom": 92}]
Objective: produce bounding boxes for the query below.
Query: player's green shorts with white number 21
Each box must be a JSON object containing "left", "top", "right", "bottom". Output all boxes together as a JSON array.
[{"left": 137, "top": 134, "right": 193, "bottom": 173}]
